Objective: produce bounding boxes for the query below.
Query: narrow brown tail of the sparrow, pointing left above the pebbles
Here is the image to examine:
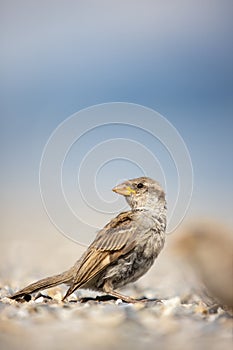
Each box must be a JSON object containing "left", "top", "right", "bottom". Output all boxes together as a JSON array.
[{"left": 9, "top": 270, "right": 72, "bottom": 299}]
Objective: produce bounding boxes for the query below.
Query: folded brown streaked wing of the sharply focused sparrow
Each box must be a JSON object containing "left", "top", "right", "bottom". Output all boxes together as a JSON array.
[{"left": 62, "top": 212, "right": 148, "bottom": 298}]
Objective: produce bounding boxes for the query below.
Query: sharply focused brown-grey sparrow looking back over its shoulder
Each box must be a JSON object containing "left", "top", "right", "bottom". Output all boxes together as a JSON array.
[{"left": 10, "top": 176, "right": 167, "bottom": 303}]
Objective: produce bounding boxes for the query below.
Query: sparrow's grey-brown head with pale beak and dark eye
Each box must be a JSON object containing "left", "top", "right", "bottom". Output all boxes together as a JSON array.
[{"left": 112, "top": 177, "right": 166, "bottom": 210}]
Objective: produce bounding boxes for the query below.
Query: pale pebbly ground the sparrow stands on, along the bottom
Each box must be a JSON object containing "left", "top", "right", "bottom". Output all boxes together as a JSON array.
[{"left": 0, "top": 286, "right": 233, "bottom": 350}]
